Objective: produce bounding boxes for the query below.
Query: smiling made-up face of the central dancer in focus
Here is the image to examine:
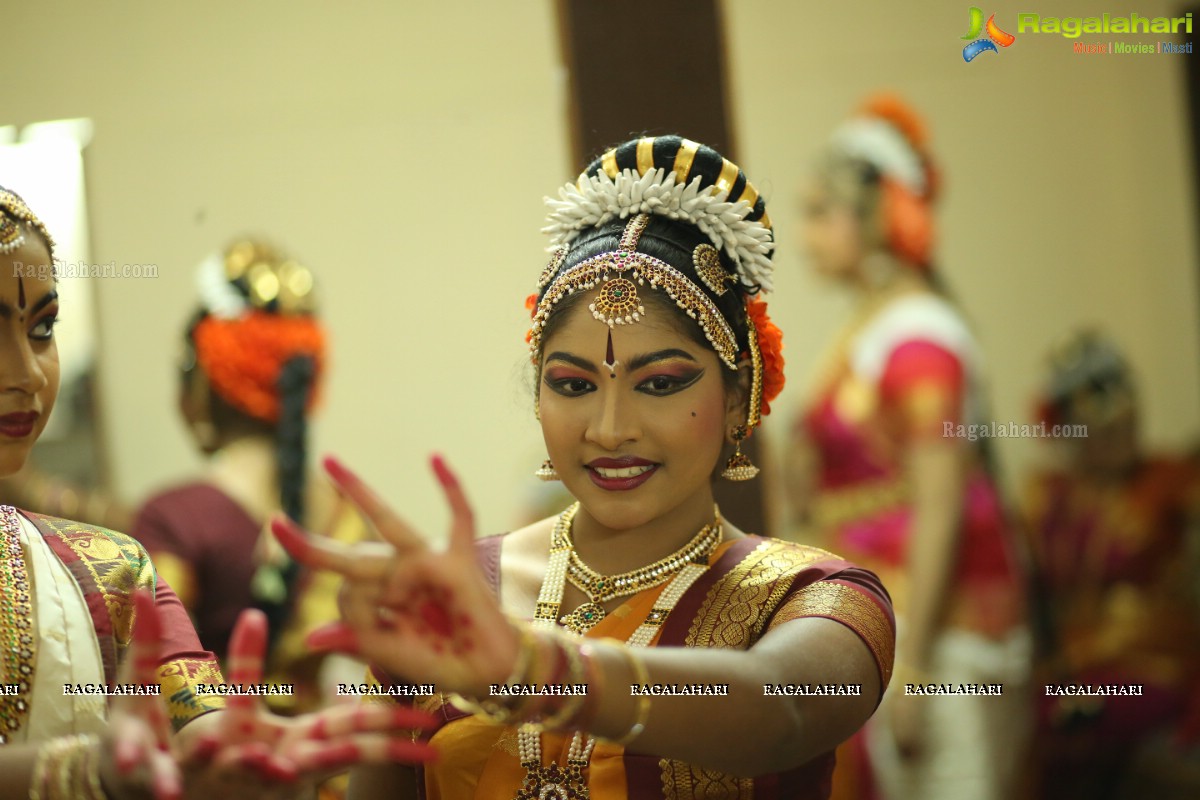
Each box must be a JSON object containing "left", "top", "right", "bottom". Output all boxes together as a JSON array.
[{"left": 538, "top": 297, "right": 745, "bottom": 530}]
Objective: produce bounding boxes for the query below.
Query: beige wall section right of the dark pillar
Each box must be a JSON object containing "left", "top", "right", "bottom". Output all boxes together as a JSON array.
[{"left": 725, "top": 0, "right": 1200, "bottom": 496}]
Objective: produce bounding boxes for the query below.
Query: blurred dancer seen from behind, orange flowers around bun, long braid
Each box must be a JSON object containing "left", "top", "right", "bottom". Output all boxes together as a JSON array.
[{"left": 132, "top": 240, "right": 362, "bottom": 712}]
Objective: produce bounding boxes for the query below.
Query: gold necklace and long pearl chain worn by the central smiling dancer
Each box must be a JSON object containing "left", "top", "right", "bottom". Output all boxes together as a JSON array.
[{"left": 515, "top": 503, "right": 724, "bottom": 800}]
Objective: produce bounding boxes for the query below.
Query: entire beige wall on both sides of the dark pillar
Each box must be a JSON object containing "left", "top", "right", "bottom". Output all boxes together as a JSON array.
[{"left": 0, "top": 0, "right": 1200, "bottom": 530}]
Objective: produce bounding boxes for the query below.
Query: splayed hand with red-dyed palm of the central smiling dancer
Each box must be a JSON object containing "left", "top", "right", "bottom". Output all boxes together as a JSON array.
[{"left": 271, "top": 457, "right": 518, "bottom": 696}]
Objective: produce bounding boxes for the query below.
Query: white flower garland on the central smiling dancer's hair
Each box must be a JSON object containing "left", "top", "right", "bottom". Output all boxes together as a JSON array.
[{"left": 541, "top": 168, "right": 775, "bottom": 291}]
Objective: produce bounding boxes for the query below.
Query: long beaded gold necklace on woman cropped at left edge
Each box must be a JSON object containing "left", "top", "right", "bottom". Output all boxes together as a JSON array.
[{"left": 0, "top": 506, "right": 35, "bottom": 745}]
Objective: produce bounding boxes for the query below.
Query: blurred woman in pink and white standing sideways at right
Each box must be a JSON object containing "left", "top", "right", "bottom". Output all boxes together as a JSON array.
[{"left": 787, "top": 96, "right": 1028, "bottom": 800}]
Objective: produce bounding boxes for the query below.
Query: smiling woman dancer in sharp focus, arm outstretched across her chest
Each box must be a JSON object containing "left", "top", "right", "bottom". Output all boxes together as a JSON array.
[{"left": 267, "top": 136, "right": 894, "bottom": 800}]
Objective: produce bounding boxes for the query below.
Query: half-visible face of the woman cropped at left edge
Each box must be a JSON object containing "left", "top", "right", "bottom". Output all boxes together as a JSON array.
[{"left": 0, "top": 231, "right": 59, "bottom": 477}]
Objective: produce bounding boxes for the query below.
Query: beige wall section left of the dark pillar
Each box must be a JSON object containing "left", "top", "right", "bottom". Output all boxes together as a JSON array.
[{"left": 0, "top": 0, "right": 570, "bottom": 530}]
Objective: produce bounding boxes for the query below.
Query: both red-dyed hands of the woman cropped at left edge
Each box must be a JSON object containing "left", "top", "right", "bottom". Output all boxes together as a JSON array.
[{"left": 101, "top": 593, "right": 436, "bottom": 800}]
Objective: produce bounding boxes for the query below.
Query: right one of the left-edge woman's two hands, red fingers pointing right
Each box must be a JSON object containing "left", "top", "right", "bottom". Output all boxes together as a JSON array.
[{"left": 180, "top": 609, "right": 437, "bottom": 795}]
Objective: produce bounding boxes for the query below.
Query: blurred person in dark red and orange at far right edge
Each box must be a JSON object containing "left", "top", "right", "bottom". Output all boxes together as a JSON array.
[{"left": 1026, "top": 331, "right": 1200, "bottom": 800}]
